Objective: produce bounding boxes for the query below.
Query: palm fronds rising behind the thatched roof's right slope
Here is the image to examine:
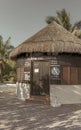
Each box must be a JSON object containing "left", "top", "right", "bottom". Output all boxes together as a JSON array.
[{"left": 46, "top": 9, "right": 81, "bottom": 38}]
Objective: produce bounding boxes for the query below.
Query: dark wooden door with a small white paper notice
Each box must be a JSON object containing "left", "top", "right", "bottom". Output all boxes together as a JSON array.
[{"left": 31, "top": 61, "right": 49, "bottom": 96}]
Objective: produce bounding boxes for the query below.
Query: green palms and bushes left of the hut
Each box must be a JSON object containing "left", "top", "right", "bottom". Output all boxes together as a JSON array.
[{"left": 0, "top": 36, "right": 16, "bottom": 82}]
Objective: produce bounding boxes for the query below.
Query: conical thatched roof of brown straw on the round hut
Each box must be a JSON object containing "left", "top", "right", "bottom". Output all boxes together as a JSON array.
[{"left": 10, "top": 22, "right": 81, "bottom": 58}]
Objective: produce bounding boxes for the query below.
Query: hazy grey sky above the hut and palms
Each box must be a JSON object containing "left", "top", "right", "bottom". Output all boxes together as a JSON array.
[{"left": 0, "top": 0, "right": 81, "bottom": 47}]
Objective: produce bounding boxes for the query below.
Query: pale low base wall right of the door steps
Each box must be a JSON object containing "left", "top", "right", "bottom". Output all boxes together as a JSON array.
[{"left": 50, "top": 85, "right": 81, "bottom": 106}]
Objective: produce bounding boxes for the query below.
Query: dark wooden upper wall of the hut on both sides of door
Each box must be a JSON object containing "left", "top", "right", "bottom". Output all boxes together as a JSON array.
[{"left": 17, "top": 54, "right": 81, "bottom": 84}]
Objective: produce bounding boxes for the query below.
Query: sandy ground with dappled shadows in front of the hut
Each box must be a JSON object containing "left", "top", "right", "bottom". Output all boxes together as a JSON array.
[{"left": 0, "top": 88, "right": 81, "bottom": 130}]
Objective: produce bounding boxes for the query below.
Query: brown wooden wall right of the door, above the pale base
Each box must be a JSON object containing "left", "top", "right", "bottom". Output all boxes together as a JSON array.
[{"left": 50, "top": 55, "right": 81, "bottom": 85}]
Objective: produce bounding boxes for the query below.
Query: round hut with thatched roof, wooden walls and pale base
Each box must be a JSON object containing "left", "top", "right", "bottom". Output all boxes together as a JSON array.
[{"left": 10, "top": 22, "right": 81, "bottom": 105}]
